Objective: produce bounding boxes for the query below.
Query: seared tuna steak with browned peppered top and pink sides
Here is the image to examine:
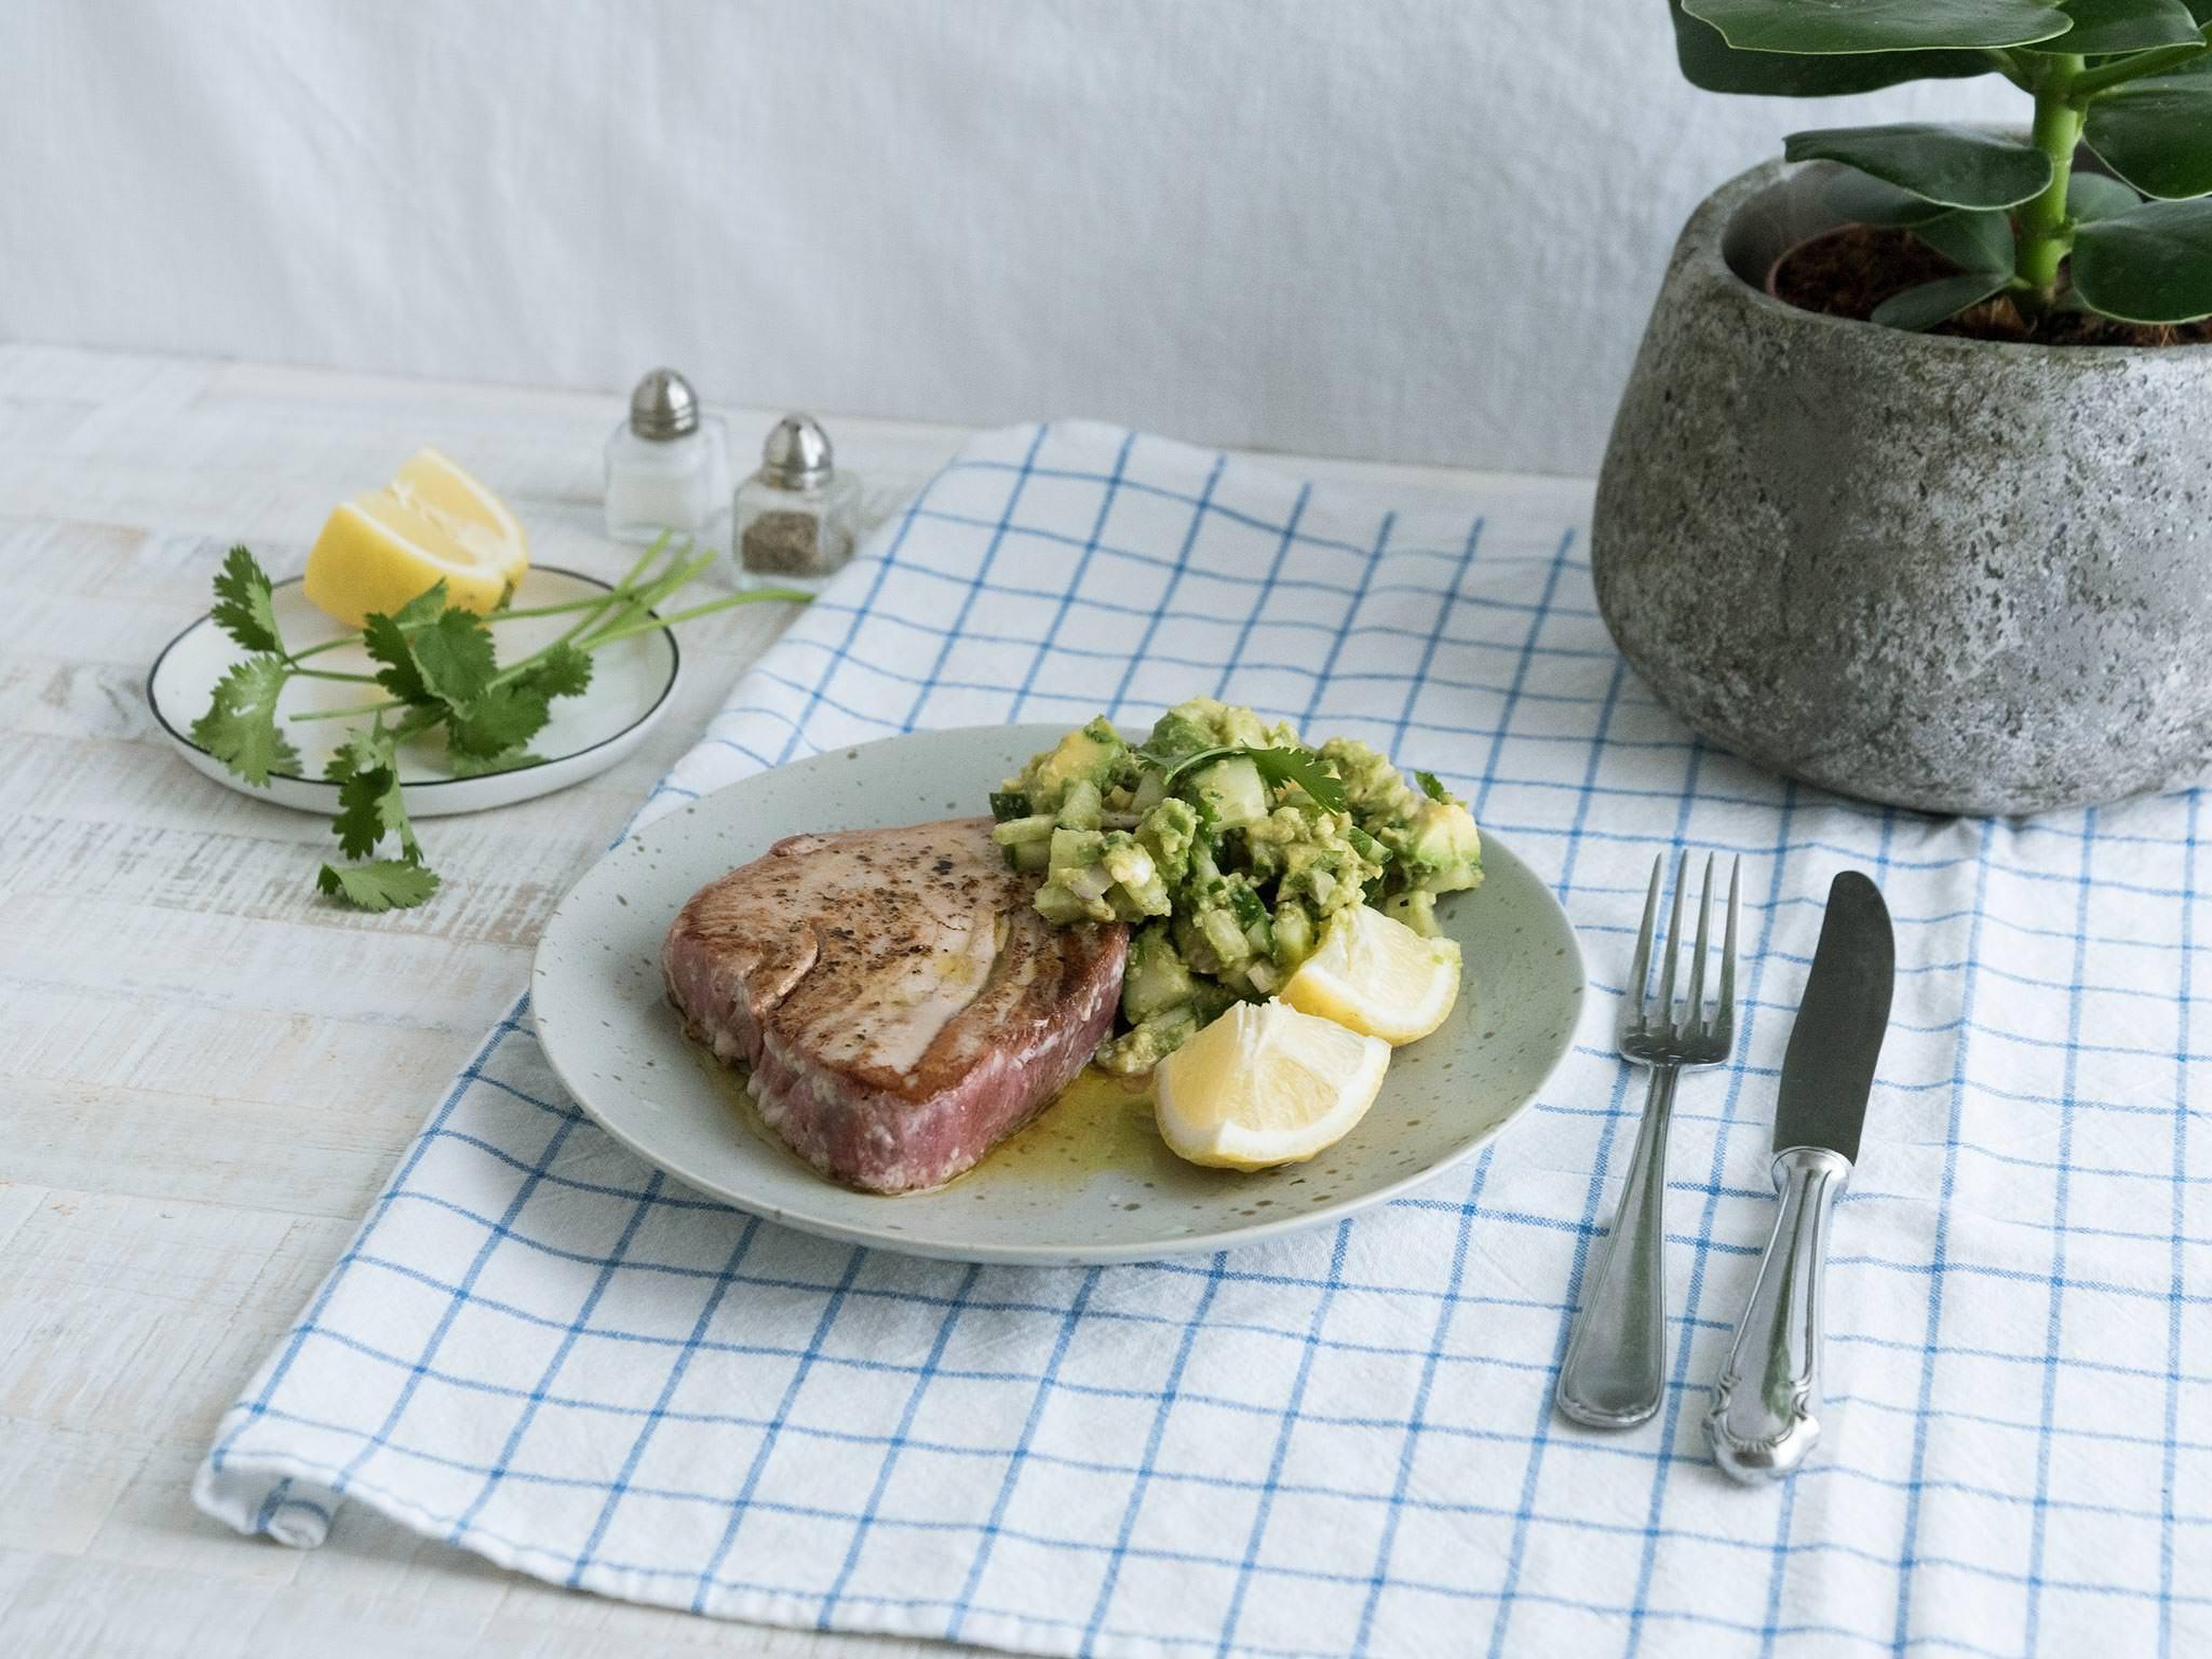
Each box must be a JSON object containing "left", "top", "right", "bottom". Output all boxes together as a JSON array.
[{"left": 661, "top": 819, "right": 1128, "bottom": 1192}]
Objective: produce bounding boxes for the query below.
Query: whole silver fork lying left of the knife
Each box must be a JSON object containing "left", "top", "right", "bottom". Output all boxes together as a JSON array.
[{"left": 1559, "top": 854, "right": 1743, "bottom": 1429}]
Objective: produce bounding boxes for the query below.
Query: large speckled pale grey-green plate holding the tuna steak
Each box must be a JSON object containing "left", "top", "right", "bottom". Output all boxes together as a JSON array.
[{"left": 531, "top": 726, "right": 1584, "bottom": 1265}]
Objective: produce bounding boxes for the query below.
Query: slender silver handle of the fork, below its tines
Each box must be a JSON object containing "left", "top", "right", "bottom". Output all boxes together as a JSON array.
[{"left": 1559, "top": 1064, "right": 1679, "bottom": 1429}]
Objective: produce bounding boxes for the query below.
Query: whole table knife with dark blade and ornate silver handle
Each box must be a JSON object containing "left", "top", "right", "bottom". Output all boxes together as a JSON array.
[{"left": 1706, "top": 869, "right": 1896, "bottom": 1480}]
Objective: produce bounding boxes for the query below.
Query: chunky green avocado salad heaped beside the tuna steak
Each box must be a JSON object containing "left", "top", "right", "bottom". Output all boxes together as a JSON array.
[{"left": 991, "top": 697, "right": 1482, "bottom": 1075}]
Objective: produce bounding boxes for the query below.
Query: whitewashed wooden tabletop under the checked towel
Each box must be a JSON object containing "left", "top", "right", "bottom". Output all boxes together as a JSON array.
[{"left": 0, "top": 345, "right": 1588, "bottom": 1659}]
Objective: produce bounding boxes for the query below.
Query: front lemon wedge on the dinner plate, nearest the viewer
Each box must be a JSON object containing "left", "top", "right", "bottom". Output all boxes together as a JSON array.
[{"left": 1154, "top": 1002, "right": 1389, "bottom": 1170}]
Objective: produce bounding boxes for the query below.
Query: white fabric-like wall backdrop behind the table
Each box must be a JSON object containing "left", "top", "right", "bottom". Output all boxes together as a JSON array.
[{"left": 0, "top": 0, "right": 2017, "bottom": 471}]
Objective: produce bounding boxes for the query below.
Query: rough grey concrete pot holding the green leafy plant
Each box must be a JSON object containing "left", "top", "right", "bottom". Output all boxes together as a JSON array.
[{"left": 1593, "top": 161, "right": 2212, "bottom": 814}]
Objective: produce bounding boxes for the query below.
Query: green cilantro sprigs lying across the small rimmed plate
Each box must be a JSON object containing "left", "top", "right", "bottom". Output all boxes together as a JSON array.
[{"left": 192, "top": 537, "right": 809, "bottom": 911}]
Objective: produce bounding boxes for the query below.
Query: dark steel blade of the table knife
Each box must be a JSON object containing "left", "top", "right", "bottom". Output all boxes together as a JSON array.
[{"left": 1774, "top": 869, "right": 1898, "bottom": 1164}]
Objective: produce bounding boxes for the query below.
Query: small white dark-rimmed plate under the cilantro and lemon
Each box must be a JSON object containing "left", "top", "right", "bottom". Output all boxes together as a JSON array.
[{"left": 146, "top": 566, "right": 681, "bottom": 819}]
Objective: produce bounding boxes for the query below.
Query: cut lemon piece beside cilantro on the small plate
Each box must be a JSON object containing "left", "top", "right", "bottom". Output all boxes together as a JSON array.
[{"left": 308, "top": 449, "right": 531, "bottom": 628}]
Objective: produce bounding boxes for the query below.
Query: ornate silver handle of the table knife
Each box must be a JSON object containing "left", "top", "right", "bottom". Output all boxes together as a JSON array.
[{"left": 1706, "top": 1146, "right": 1851, "bottom": 1482}]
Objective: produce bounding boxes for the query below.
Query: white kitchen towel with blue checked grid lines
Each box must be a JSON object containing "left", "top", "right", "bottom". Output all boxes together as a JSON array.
[{"left": 197, "top": 425, "right": 2212, "bottom": 1659}]
